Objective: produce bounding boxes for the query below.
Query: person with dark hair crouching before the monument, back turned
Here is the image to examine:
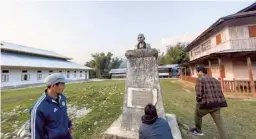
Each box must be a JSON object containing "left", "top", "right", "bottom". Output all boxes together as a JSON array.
[{"left": 139, "top": 104, "right": 173, "bottom": 139}]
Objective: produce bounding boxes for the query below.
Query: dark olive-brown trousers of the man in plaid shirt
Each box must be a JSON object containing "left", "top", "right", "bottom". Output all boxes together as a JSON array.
[{"left": 195, "top": 105, "right": 227, "bottom": 139}]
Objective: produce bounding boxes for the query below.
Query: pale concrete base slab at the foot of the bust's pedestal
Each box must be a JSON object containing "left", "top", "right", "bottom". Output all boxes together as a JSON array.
[{"left": 102, "top": 114, "right": 182, "bottom": 139}]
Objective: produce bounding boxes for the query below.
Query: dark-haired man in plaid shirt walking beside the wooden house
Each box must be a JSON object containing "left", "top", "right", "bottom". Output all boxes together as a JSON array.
[{"left": 191, "top": 65, "right": 227, "bottom": 139}]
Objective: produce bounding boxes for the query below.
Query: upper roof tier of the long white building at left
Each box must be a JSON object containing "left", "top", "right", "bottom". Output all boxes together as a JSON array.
[{"left": 0, "top": 41, "right": 71, "bottom": 59}]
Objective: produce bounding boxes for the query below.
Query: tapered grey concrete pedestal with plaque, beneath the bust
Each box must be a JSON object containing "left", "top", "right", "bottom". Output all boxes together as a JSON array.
[{"left": 103, "top": 49, "right": 181, "bottom": 139}]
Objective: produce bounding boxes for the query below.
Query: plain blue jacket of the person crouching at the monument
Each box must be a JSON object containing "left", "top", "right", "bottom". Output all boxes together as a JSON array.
[{"left": 139, "top": 118, "right": 173, "bottom": 139}]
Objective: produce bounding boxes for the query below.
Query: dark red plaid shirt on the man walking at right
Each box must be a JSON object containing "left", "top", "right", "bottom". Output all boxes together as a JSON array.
[{"left": 195, "top": 75, "right": 227, "bottom": 109}]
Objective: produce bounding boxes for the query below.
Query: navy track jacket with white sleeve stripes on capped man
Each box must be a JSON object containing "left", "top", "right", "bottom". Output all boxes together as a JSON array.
[{"left": 30, "top": 92, "right": 72, "bottom": 139}]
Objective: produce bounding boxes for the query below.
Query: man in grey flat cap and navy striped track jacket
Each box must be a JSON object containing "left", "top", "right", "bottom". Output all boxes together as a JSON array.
[{"left": 30, "top": 73, "right": 72, "bottom": 139}]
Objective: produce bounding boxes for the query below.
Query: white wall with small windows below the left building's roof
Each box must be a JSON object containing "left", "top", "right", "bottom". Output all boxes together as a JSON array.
[{"left": 1, "top": 67, "right": 89, "bottom": 87}]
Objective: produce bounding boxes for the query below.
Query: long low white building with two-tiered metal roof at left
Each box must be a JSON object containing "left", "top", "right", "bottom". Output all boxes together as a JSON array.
[{"left": 0, "top": 42, "right": 91, "bottom": 88}]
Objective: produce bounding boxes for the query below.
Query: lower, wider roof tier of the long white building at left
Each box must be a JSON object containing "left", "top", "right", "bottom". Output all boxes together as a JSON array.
[{"left": 1, "top": 52, "right": 91, "bottom": 69}]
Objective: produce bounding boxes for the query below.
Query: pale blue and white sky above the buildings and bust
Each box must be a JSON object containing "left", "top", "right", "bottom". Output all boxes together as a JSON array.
[{"left": 0, "top": 1, "right": 253, "bottom": 64}]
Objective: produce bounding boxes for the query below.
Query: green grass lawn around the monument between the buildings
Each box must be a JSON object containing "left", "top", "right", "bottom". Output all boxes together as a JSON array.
[{"left": 1, "top": 80, "right": 256, "bottom": 139}]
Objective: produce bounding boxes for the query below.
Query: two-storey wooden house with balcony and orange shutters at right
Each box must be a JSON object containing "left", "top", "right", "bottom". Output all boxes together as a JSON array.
[{"left": 182, "top": 3, "right": 256, "bottom": 93}]
